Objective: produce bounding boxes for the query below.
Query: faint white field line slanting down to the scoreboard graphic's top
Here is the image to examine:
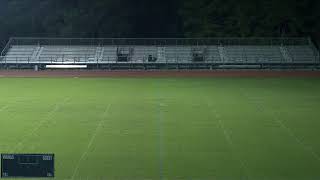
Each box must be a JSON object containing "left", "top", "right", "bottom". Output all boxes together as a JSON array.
[{"left": 12, "top": 98, "right": 70, "bottom": 152}]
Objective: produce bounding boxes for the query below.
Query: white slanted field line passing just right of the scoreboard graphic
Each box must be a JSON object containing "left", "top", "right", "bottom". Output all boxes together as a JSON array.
[{"left": 71, "top": 104, "right": 111, "bottom": 179}]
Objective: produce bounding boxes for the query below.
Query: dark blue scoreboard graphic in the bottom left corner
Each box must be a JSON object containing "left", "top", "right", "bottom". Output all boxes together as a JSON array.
[{"left": 1, "top": 154, "right": 54, "bottom": 178}]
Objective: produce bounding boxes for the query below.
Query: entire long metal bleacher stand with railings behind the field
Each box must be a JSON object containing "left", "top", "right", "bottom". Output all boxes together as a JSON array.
[{"left": 0, "top": 38, "right": 320, "bottom": 69}]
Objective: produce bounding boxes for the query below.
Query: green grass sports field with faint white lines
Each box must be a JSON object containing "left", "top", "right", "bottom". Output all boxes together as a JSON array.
[{"left": 0, "top": 78, "right": 320, "bottom": 180}]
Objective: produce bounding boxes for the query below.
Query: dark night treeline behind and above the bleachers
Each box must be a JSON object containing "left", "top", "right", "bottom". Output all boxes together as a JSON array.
[{"left": 0, "top": 0, "right": 320, "bottom": 46}]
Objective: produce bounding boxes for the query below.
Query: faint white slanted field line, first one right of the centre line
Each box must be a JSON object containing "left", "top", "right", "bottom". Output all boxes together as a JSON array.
[{"left": 207, "top": 102, "right": 249, "bottom": 179}]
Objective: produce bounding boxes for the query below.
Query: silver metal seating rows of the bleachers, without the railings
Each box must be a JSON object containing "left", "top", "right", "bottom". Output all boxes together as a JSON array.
[{"left": 1, "top": 45, "right": 317, "bottom": 64}]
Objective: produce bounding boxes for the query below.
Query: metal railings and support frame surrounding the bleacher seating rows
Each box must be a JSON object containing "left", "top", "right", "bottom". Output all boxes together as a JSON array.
[{"left": 0, "top": 37, "right": 320, "bottom": 70}]
